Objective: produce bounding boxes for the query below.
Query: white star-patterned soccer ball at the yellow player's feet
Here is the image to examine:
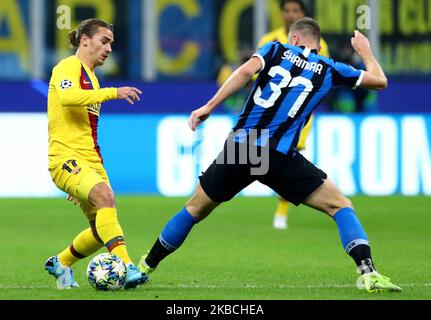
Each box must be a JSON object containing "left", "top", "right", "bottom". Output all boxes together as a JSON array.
[{"left": 87, "top": 253, "right": 126, "bottom": 291}]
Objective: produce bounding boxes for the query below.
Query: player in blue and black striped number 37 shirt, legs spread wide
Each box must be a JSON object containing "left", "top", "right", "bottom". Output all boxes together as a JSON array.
[{"left": 138, "top": 18, "right": 401, "bottom": 292}]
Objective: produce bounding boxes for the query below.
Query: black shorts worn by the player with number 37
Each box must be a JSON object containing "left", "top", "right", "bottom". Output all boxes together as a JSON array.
[{"left": 199, "top": 143, "right": 327, "bottom": 206}]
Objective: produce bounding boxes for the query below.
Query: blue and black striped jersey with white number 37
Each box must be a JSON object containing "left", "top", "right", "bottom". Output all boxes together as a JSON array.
[{"left": 233, "top": 41, "right": 364, "bottom": 154}]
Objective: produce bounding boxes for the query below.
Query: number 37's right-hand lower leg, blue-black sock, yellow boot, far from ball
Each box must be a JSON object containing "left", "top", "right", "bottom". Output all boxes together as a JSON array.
[{"left": 304, "top": 179, "right": 401, "bottom": 292}]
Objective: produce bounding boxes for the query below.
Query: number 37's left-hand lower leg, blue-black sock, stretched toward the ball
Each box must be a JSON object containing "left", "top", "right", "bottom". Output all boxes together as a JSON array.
[{"left": 138, "top": 184, "right": 218, "bottom": 274}]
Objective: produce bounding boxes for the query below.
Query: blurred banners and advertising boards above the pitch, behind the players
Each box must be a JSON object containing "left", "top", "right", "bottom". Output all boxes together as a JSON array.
[{"left": 0, "top": 0, "right": 431, "bottom": 197}]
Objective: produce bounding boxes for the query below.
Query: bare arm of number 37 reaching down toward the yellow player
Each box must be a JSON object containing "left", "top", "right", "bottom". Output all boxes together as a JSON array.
[{"left": 189, "top": 56, "right": 263, "bottom": 131}]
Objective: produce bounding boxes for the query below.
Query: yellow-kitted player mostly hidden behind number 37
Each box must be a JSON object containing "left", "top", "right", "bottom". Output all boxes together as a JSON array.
[{"left": 258, "top": 0, "right": 329, "bottom": 229}]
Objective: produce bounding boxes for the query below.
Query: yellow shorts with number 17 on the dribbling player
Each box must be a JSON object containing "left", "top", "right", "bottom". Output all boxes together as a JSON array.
[{"left": 50, "top": 159, "right": 111, "bottom": 221}]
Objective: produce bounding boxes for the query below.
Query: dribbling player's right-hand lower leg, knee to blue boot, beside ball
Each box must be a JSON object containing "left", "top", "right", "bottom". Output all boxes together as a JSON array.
[{"left": 89, "top": 183, "right": 148, "bottom": 289}]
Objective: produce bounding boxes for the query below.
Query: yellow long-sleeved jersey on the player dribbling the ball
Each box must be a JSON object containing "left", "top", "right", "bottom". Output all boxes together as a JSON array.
[{"left": 48, "top": 56, "right": 117, "bottom": 169}]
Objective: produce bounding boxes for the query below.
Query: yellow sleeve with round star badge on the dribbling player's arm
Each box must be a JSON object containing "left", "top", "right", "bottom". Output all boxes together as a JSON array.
[{"left": 52, "top": 65, "right": 117, "bottom": 107}]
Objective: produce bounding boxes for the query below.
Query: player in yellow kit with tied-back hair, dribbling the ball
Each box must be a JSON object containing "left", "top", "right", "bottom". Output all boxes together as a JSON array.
[{"left": 45, "top": 19, "right": 147, "bottom": 289}]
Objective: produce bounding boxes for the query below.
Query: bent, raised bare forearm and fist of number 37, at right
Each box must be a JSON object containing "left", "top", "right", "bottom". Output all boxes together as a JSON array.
[{"left": 352, "top": 30, "right": 388, "bottom": 90}]
